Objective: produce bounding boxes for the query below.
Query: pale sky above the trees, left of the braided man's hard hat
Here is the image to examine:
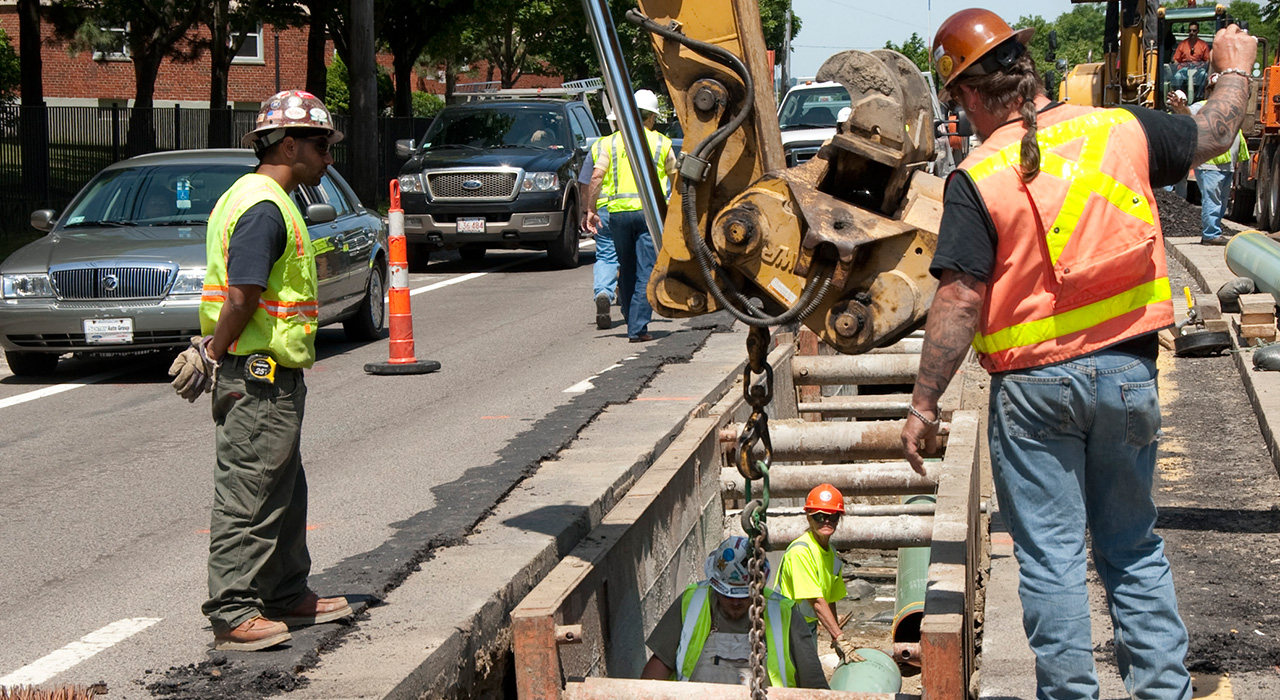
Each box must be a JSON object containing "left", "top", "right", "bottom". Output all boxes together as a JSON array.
[{"left": 791, "top": 0, "right": 1071, "bottom": 77}]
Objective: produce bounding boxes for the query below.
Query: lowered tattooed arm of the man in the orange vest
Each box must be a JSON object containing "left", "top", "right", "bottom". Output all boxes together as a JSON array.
[{"left": 902, "top": 270, "right": 987, "bottom": 475}]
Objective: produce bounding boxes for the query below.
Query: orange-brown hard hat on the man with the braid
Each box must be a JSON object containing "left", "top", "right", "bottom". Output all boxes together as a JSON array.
[{"left": 932, "top": 8, "right": 1036, "bottom": 87}]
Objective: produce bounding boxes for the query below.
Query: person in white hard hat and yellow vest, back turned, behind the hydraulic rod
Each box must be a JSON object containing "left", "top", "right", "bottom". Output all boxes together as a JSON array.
[{"left": 581, "top": 90, "right": 676, "bottom": 343}]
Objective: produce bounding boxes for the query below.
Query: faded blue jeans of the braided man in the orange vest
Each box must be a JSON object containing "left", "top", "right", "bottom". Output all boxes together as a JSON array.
[{"left": 988, "top": 351, "right": 1192, "bottom": 700}]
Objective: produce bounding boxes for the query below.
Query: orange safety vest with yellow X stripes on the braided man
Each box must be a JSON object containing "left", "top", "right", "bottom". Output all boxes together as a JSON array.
[{"left": 960, "top": 105, "right": 1174, "bottom": 372}]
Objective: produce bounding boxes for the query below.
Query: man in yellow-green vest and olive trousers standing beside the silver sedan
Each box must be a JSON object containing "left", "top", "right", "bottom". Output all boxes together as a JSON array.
[{"left": 169, "top": 90, "right": 352, "bottom": 651}]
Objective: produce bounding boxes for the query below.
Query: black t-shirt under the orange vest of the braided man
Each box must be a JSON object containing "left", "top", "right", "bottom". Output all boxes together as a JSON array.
[{"left": 929, "top": 102, "right": 1197, "bottom": 356}]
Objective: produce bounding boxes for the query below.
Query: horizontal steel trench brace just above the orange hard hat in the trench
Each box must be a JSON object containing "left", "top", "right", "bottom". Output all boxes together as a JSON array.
[{"left": 721, "top": 462, "right": 938, "bottom": 508}]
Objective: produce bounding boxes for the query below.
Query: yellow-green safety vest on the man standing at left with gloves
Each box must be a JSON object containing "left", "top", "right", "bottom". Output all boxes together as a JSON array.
[{"left": 200, "top": 173, "right": 320, "bottom": 369}]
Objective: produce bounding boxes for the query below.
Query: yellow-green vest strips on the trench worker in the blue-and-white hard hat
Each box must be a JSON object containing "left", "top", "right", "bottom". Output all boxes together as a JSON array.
[{"left": 676, "top": 581, "right": 795, "bottom": 687}]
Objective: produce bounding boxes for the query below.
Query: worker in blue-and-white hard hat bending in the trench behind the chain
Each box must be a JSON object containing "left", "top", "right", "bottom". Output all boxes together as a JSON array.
[{"left": 640, "top": 535, "right": 828, "bottom": 690}]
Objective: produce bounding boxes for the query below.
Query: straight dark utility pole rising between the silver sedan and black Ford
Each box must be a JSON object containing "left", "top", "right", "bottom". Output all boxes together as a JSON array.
[{"left": 347, "top": 0, "right": 379, "bottom": 207}]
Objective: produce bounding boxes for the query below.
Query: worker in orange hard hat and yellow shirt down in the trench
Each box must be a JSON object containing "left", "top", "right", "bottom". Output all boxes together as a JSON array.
[{"left": 774, "top": 484, "right": 863, "bottom": 663}]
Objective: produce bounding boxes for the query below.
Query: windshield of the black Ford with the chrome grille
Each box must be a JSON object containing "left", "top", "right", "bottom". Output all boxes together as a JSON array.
[{"left": 422, "top": 105, "right": 570, "bottom": 150}]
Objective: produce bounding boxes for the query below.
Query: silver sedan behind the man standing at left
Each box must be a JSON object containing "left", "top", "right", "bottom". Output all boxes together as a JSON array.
[{"left": 0, "top": 150, "right": 387, "bottom": 376}]
